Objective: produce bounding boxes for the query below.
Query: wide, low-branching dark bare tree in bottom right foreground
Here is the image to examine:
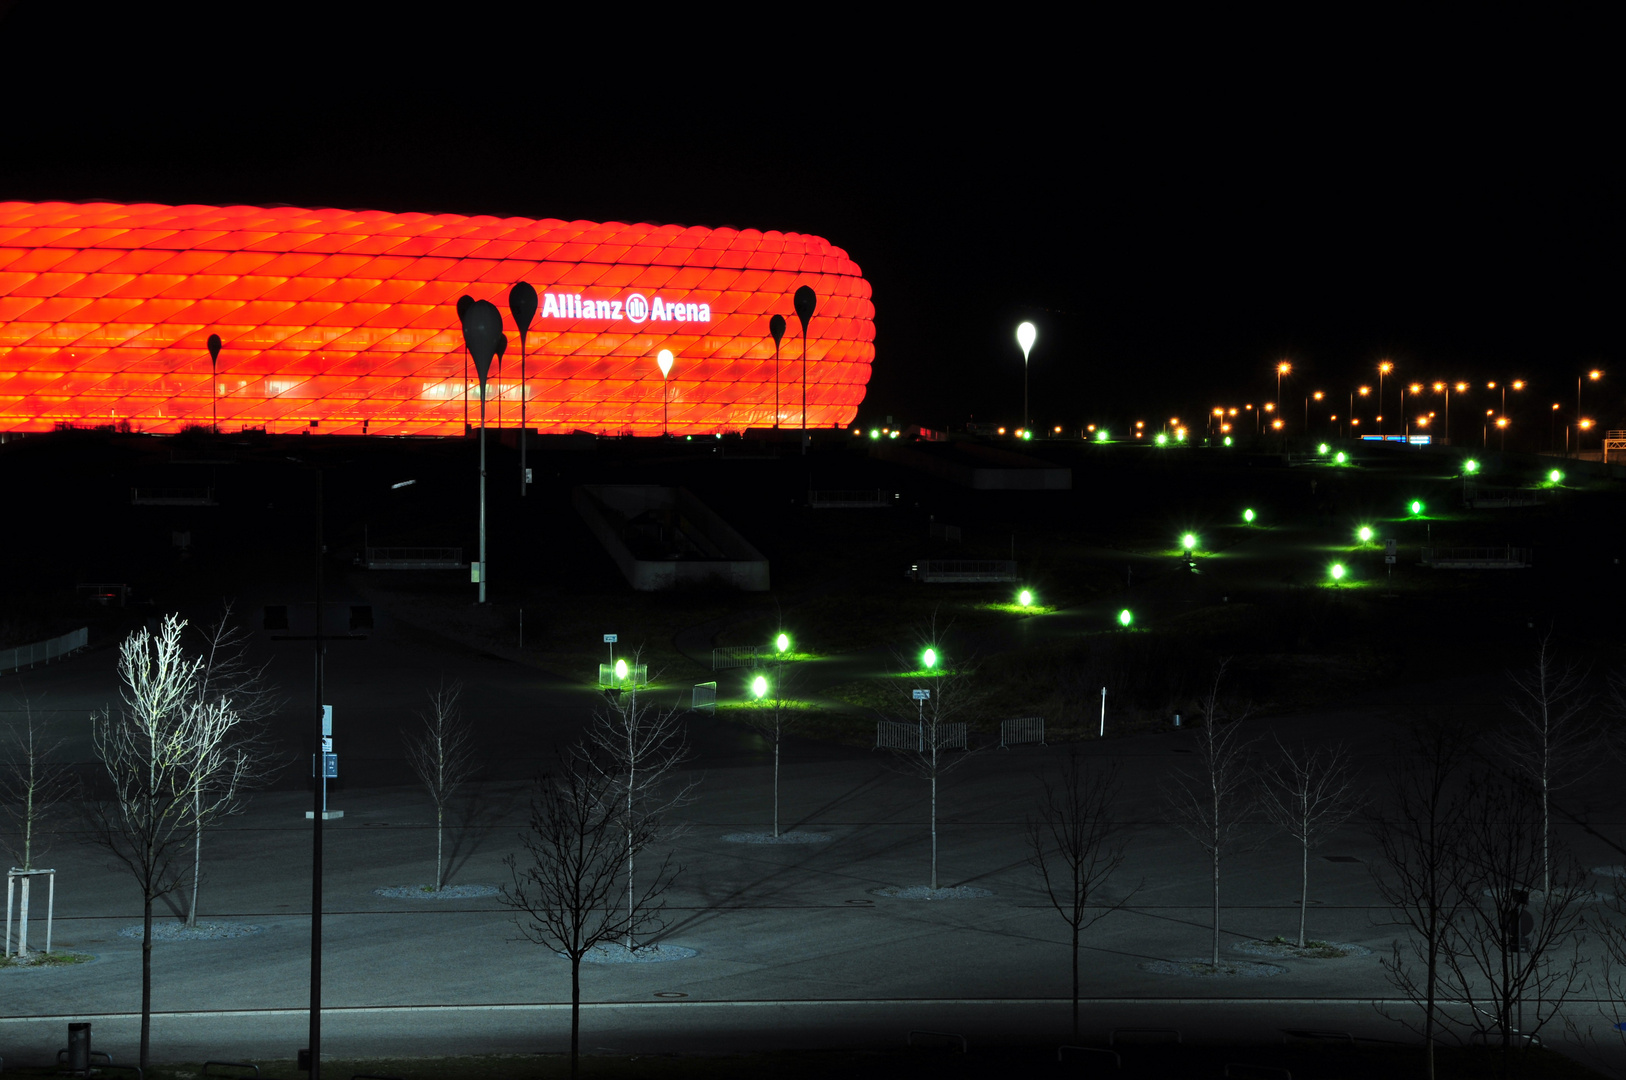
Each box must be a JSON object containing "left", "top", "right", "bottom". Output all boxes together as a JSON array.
[{"left": 1442, "top": 779, "right": 1590, "bottom": 1077}]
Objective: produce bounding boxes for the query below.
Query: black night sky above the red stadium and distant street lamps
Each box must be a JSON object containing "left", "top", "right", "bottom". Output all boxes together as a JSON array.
[{"left": 0, "top": 3, "right": 1626, "bottom": 429}]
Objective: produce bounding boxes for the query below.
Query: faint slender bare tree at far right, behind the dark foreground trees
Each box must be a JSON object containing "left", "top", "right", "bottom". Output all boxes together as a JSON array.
[{"left": 1494, "top": 629, "right": 1605, "bottom": 891}]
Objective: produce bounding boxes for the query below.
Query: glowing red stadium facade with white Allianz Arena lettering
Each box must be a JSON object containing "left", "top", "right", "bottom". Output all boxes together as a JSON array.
[{"left": 0, "top": 202, "right": 875, "bottom": 434}]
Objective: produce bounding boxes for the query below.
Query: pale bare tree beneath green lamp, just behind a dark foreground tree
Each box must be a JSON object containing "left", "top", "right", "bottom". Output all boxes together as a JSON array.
[{"left": 584, "top": 657, "right": 699, "bottom": 950}]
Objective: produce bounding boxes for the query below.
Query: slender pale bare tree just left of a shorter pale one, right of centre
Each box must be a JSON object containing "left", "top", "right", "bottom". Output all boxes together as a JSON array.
[{"left": 1167, "top": 657, "right": 1255, "bottom": 968}]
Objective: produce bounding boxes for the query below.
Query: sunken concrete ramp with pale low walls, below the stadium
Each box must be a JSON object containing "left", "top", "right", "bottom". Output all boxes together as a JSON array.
[{"left": 571, "top": 485, "right": 767, "bottom": 592}]
